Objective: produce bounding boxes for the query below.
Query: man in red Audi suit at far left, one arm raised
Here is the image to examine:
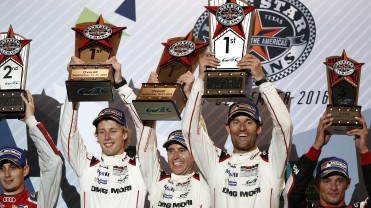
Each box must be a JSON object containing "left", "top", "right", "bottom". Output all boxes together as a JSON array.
[{"left": 0, "top": 91, "right": 63, "bottom": 208}]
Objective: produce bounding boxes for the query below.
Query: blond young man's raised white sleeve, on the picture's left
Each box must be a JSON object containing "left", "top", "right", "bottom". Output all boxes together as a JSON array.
[{"left": 60, "top": 98, "right": 91, "bottom": 177}]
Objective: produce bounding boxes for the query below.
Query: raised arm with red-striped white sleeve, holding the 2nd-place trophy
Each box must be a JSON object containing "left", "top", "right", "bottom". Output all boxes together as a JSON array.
[{"left": 21, "top": 91, "right": 63, "bottom": 207}]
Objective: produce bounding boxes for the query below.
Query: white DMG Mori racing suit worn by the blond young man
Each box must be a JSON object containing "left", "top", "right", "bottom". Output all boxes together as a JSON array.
[{"left": 61, "top": 96, "right": 147, "bottom": 208}]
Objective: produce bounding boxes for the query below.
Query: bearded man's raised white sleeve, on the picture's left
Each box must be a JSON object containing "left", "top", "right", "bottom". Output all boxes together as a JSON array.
[{"left": 182, "top": 78, "right": 221, "bottom": 180}]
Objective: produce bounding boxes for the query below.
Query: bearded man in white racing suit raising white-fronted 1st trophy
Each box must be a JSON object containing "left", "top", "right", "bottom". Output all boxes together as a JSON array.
[{"left": 182, "top": 52, "right": 293, "bottom": 208}]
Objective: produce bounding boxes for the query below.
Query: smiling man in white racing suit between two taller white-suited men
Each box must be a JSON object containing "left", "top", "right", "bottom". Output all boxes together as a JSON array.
[{"left": 119, "top": 71, "right": 211, "bottom": 208}]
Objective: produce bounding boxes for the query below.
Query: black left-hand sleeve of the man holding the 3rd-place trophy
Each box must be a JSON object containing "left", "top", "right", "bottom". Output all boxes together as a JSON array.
[{"left": 285, "top": 154, "right": 317, "bottom": 208}]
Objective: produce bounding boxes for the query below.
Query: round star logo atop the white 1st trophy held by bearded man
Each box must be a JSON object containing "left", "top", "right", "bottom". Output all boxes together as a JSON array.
[{"left": 216, "top": 3, "right": 245, "bottom": 26}]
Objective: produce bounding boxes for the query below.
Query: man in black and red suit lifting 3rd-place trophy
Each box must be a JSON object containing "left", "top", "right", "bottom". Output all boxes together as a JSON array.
[{"left": 284, "top": 112, "right": 371, "bottom": 208}]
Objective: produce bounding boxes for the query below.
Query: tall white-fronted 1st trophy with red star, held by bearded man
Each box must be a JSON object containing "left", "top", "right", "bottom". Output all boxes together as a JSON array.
[{"left": 203, "top": 0, "right": 256, "bottom": 102}]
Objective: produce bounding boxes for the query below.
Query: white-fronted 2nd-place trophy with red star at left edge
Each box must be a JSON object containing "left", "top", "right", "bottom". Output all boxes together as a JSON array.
[{"left": 0, "top": 25, "right": 31, "bottom": 119}]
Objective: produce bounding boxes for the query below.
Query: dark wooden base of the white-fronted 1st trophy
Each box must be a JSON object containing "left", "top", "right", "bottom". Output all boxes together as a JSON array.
[{"left": 202, "top": 70, "right": 252, "bottom": 102}]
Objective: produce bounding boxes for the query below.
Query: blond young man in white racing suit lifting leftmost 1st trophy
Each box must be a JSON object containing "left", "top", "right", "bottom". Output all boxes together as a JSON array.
[{"left": 61, "top": 57, "right": 147, "bottom": 208}]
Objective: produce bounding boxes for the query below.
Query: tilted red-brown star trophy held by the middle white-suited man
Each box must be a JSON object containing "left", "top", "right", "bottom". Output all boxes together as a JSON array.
[{"left": 133, "top": 31, "right": 209, "bottom": 120}]
